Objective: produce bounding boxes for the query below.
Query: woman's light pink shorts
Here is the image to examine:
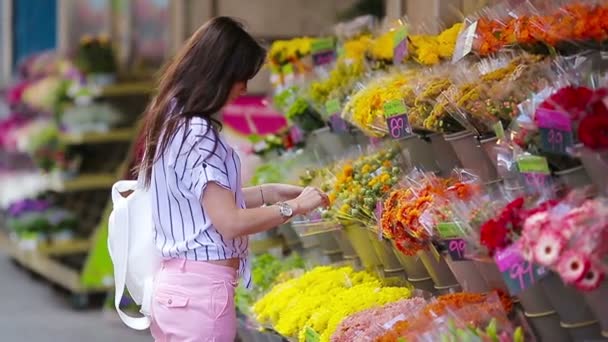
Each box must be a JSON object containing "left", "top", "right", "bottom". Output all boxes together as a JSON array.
[{"left": 150, "top": 259, "right": 237, "bottom": 342}]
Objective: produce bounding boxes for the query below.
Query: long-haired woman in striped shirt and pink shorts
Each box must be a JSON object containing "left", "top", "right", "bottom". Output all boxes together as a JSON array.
[{"left": 139, "top": 17, "right": 328, "bottom": 342}]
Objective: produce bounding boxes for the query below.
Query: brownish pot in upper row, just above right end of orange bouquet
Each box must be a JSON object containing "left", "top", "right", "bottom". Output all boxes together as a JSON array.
[{"left": 444, "top": 131, "right": 498, "bottom": 182}]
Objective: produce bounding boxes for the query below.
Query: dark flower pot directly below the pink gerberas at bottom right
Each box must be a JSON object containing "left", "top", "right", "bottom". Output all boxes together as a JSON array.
[{"left": 540, "top": 273, "right": 601, "bottom": 341}]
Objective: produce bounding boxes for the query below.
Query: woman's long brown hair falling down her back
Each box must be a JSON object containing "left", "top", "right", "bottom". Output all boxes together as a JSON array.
[{"left": 137, "top": 17, "right": 266, "bottom": 186}]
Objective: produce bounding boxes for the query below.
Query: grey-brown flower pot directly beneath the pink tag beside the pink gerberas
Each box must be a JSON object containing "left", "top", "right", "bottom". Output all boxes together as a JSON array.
[{"left": 517, "top": 283, "right": 570, "bottom": 342}]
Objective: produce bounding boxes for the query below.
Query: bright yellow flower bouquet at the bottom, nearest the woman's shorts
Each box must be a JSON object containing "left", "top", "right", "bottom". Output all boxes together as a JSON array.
[{"left": 253, "top": 266, "right": 411, "bottom": 341}]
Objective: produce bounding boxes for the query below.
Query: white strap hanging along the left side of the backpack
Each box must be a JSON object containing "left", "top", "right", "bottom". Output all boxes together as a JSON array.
[{"left": 108, "top": 181, "right": 150, "bottom": 330}]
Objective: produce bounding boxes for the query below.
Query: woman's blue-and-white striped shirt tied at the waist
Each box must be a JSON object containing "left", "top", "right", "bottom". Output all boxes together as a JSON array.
[{"left": 150, "top": 107, "right": 251, "bottom": 288}]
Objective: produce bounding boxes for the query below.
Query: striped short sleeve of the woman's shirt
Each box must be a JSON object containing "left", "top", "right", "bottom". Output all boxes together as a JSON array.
[{"left": 169, "top": 122, "right": 232, "bottom": 198}]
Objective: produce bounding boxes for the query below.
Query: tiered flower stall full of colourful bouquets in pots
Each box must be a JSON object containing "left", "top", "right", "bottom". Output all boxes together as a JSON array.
[{"left": 238, "top": 1, "right": 608, "bottom": 341}]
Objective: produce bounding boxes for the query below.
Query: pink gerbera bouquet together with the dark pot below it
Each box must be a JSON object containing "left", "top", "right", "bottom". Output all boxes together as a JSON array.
[{"left": 517, "top": 193, "right": 608, "bottom": 339}]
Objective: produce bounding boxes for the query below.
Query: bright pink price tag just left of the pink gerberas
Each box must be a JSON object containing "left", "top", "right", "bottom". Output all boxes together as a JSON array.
[{"left": 494, "top": 245, "right": 548, "bottom": 296}]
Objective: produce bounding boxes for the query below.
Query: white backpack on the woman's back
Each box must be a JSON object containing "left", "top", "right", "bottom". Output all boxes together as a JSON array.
[{"left": 108, "top": 181, "right": 161, "bottom": 330}]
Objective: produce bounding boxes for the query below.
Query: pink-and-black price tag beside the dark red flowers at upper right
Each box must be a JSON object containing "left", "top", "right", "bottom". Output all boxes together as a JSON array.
[{"left": 534, "top": 108, "right": 574, "bottom": 154}]
